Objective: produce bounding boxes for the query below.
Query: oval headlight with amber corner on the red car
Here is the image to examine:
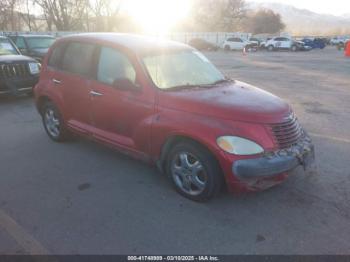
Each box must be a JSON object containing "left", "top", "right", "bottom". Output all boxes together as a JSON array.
[{"left": 216, "top": 136, "right": 264, "bottom": 156}]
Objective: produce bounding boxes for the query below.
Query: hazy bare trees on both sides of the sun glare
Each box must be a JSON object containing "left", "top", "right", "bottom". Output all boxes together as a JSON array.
[{"left": 0, "top": 0, "right": 285, "bottom": 34}]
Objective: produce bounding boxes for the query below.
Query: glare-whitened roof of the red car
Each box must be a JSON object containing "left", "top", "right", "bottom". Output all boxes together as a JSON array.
[{"left": 59, "top": 33, "right": 193, "bottom": 54}]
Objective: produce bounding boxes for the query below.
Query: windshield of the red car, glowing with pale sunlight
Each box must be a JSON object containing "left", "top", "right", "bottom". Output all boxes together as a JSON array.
[{"left": 143, "top": 50, "right": 225, "bottom": 89}]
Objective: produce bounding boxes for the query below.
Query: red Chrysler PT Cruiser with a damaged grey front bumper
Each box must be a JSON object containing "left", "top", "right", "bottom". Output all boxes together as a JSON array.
[{"left": 35, "top": 34, "right": 314, "bottom": 201}]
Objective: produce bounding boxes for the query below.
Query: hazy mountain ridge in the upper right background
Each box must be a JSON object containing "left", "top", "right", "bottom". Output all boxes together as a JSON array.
[{"left": 248, "top": 2, "right": 350, "bottom": 36}]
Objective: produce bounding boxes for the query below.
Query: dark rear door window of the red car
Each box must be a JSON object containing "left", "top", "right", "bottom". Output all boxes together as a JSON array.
[{"left": 62, "top": 42, "right": 95, "bottom": 76}]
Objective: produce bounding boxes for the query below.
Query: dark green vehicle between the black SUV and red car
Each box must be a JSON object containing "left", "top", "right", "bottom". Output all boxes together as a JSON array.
[{"left": 9, "top": 35, "right": 56, "bottom": 62}]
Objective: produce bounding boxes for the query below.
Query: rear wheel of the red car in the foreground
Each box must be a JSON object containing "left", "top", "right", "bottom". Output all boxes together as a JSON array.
[{"left": 41, "top": 102, "right": 73, "bottom": 142}]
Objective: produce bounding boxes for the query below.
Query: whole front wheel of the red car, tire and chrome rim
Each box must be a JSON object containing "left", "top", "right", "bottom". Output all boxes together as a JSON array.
[{"left": 165, "top": 141, "right": 223, "bottom": 202}]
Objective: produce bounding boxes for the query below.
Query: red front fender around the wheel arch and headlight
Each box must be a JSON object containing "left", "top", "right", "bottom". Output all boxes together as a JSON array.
[{"left": 151, "top": 108, "right": 274, "bottom": 190}]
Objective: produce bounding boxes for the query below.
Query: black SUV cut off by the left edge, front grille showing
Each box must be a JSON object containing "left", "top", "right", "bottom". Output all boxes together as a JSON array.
[{"left": 0, "top": 36, "right": 41, "bottom": 95}]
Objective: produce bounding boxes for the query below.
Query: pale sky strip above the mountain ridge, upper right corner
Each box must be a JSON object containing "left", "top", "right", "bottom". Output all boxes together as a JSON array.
[{"left": 247, "top": 0, "right": 350, "bottom": 16}]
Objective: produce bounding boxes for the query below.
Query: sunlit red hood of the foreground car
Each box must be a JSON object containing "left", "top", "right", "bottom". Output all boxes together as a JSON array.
[{"left": 159, "top": 81, "right": 291, "bottom": 123}]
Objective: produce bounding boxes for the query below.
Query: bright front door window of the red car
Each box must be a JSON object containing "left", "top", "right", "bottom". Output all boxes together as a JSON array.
[{"left": 97, "top": 47, "right": 136, "bottom": 85}]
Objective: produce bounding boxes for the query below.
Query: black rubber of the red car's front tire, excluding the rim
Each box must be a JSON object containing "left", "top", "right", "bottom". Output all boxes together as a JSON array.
[{"left": 166, "top": 142, "right": 223, "bottom": 202}]
